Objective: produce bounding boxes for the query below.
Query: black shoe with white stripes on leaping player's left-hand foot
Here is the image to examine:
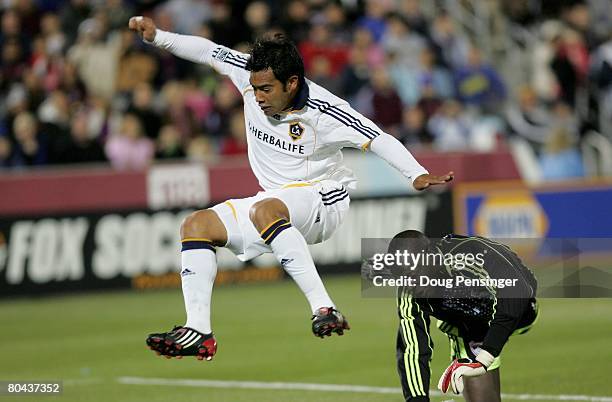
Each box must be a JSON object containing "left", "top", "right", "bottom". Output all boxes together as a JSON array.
[{"left": 147, "top": 326, "right": 217, "bottom": 360}]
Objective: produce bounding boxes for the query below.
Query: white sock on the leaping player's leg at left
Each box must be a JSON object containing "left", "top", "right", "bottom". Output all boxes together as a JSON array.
[{"left": 181, "top": 242, "right": 217, "bottom": 334}]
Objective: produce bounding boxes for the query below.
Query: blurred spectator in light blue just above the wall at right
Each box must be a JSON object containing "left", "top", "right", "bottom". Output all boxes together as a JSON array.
[{"left": 539, "top": 127, "right": 584, "bottom": 180}]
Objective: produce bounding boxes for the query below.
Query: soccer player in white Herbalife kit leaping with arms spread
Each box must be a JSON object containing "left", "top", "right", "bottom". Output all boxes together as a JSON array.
[{"left": 129, "top": 17, "right": 453, "bottom": 360}]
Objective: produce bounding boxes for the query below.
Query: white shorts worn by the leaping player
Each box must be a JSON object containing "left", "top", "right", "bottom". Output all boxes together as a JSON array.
[{"left": 211, "top": 180, "right": 350, "bottom": 261}]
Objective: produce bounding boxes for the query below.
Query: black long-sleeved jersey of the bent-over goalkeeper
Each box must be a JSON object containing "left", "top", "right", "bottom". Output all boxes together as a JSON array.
[{"left": 399, "top": 234, "right": 537, "bottom": 356}]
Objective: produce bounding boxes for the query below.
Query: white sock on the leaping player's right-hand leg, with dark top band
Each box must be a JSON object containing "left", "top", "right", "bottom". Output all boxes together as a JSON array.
[{"left": 262, "top": 221, "right": 335, "bottom": 313}]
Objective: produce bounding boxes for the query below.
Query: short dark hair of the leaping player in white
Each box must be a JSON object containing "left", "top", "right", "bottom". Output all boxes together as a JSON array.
[{"left": 245, "top": 33, "right": 304, "bottom": 85}]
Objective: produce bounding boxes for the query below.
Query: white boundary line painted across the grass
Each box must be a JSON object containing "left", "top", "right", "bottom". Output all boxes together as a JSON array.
[{"left": 117, "top": 377, "right": 612, "bottom": 402}]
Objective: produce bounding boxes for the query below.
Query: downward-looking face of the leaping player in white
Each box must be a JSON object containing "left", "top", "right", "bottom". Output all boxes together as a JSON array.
[{"left": 250, "top": 68, "right": 298, "bottom": 116}]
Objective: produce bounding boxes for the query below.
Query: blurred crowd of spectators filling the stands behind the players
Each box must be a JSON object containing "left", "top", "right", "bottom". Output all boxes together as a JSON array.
[{"left": 0, "top": 0, "right": 612, "bottom": 178}]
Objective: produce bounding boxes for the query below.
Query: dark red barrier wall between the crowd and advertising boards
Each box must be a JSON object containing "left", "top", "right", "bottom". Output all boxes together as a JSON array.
[{"left": 0, "top": 151, "right": 519, "bottom": 216}]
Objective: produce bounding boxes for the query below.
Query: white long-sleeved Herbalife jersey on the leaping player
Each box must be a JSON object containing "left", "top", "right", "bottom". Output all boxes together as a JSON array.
[{"left": 154, "top": 30, "right": 427, "bottom": 190}]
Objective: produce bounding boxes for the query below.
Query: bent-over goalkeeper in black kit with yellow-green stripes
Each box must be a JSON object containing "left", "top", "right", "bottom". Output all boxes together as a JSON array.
[{"left": 370, "top": 230, "right": 538, "bottom": 402}]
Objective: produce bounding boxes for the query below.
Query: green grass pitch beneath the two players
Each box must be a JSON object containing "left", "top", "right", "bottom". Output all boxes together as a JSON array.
[{"left": 0, "top": 276, "right": 612, "bottom": 402}]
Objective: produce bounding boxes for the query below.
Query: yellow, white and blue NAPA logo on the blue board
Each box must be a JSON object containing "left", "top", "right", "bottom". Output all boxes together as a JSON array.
[{"left": 474, "top": 191, "right": 548, "bottom": 239}]
